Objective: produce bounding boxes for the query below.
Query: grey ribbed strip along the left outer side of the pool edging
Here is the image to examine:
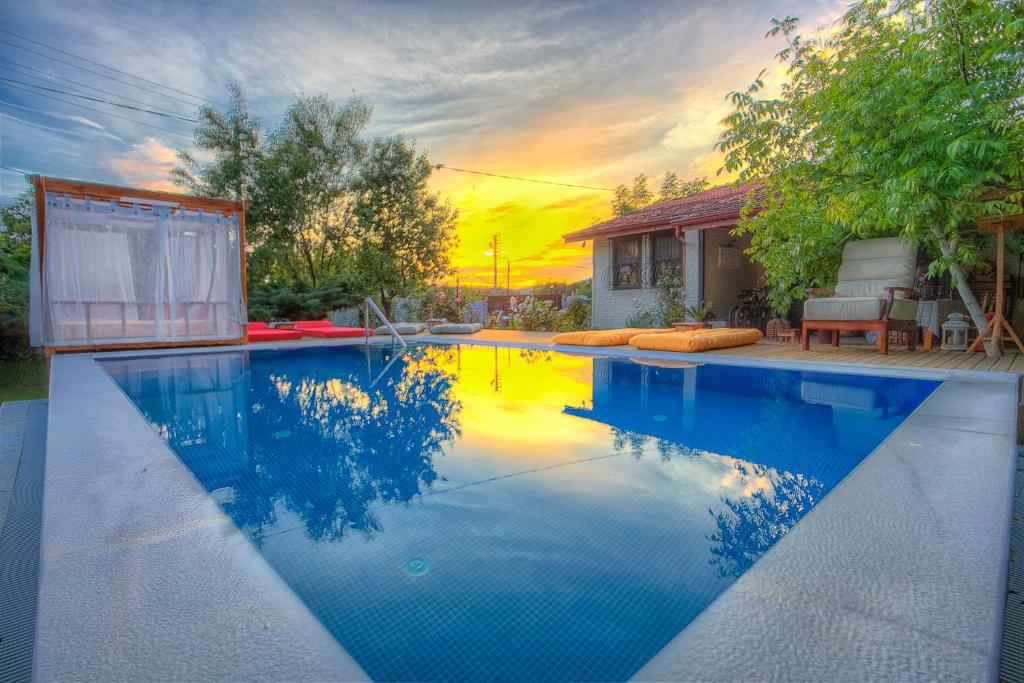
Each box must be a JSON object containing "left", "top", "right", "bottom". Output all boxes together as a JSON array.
[{"left": 0, "top": 400, "right": 46, "bottom": 683}]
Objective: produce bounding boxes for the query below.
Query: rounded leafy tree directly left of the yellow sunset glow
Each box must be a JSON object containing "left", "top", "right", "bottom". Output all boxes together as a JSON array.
[{"left": 345, "top": 135, "right": 458, "bottom": 315}]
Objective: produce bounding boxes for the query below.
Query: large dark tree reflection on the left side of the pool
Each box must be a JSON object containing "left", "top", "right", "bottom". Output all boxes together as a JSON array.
[{"left": 230, "top": 348, "right": 462, "bottom": 543}]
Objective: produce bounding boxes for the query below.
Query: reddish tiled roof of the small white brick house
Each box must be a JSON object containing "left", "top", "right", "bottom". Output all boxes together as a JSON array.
[{"left": 562, "top": 183, "right": 759, "bottom": 242}]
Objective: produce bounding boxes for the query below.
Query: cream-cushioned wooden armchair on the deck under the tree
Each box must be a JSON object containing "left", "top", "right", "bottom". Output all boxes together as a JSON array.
[{"left": 801, "top": 238, "right": 918, "bottom": 355}]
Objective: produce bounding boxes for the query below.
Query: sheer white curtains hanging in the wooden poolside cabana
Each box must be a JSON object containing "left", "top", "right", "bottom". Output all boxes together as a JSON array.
[{"left": 41, "top": 194, "right": 246, "bottom": 346}]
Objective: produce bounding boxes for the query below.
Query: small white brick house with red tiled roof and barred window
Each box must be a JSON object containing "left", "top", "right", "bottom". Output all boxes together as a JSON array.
[{"left": 562, "top": 184, "right": 764, "bottom": 330}]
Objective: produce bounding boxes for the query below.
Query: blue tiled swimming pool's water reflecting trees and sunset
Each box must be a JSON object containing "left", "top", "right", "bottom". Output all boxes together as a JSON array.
[{"left": 103, "top": 344, "right": 938, "bottom": 681}]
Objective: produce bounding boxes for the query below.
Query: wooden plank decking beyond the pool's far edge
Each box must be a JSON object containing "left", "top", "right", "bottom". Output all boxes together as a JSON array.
[{"left": 432, "top": 330, "right": 1024, "bottom": 375}]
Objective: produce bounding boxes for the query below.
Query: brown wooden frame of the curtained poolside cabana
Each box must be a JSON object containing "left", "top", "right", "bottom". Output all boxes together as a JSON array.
[{"left": 29, "top": 175, "right": 249, "bottom": 356}]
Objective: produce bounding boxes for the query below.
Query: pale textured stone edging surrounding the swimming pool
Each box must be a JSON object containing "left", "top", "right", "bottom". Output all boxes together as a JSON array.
[{"left": 35, "top": 338, "right": 1019, "bottom": 680}]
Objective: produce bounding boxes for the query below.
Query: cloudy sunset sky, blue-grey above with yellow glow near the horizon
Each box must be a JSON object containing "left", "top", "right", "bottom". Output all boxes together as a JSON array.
[{"left": 0, "top": 0, "right": 846, "bottom": 287}]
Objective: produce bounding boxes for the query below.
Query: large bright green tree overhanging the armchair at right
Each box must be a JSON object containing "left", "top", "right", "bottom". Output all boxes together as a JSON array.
[{"left": 718, "top": 0, "right": 1024, "bottom": 352}]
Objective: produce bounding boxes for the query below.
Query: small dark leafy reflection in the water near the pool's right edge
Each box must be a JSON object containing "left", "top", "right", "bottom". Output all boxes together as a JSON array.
[{"left": 708, "top": 463, "right": 823, "bottom": 577}]
